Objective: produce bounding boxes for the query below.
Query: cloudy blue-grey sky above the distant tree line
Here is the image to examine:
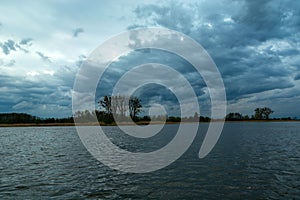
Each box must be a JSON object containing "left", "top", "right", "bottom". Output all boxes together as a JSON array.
[{"left": 0, "top": 0, "right": 300, "bottom": 118}]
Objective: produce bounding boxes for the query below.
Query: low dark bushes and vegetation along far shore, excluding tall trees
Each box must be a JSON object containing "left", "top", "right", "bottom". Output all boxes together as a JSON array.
[{"left": 0, "top": 111, "right": 300, "bottom": 127}]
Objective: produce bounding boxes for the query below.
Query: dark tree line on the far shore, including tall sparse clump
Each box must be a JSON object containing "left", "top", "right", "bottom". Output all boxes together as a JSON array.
[{"left": 0, "top": 102, "right": 292, "bottom": 124}]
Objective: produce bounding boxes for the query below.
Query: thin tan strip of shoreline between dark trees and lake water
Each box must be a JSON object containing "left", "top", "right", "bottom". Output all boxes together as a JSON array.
[{"left": 0, "top": 120, "right": 300, "bottom": 128}]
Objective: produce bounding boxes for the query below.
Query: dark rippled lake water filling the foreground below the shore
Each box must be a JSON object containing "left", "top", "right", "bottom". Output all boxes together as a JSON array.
[{"left": 0, "top": 122, "right": 300, "bottom": 199}]
